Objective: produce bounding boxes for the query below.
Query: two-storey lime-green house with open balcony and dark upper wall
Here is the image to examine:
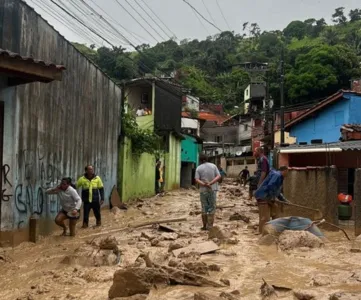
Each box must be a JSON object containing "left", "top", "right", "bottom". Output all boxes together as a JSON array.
[{"left": 119, "top": 78, "right": 182, "bottom": 201}]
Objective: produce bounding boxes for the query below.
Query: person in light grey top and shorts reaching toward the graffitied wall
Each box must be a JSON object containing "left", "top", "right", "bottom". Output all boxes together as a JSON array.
[{"left": 46, "top": 177, "right": 82, "bottom": 236}]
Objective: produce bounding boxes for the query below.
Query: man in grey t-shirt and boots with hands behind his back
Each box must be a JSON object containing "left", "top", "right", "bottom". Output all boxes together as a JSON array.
[{"left": 195, "top": 155, "right": 222, "bottom": 230}]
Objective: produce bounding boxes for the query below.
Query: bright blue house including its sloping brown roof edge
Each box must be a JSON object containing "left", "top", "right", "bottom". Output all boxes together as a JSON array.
[{"left": 285, "top": 91, "right": 361, "bottom": 144}]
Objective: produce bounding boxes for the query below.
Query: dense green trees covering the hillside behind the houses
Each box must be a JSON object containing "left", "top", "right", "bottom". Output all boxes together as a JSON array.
[{"left": 74, "top": 7, "right": 361, "bottom": 112}]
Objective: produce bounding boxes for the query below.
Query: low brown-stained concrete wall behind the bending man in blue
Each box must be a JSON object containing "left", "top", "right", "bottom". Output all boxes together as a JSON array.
[{"left": 283, "top": 167, "right": 338, "bottom": 225}]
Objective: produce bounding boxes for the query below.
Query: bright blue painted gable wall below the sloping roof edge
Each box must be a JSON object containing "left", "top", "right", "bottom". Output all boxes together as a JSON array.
[{"left": 290, "top": 98, "right": 348, "bottom": 143}]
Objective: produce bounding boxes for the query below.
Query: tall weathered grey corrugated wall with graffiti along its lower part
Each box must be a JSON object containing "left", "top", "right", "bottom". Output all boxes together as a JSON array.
[{"left": 0, "top": 0, "right": 121, "bottom": 234}]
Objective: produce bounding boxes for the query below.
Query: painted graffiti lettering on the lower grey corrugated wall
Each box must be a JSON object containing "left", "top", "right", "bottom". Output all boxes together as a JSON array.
[{"left": 1, "top": 145, "right": 107, "bottom": 228}]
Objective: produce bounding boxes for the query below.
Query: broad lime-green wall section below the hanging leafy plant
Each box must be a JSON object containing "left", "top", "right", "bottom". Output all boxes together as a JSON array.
[{"left": 119, "top": 138, "right": 155, "bottom": 202}]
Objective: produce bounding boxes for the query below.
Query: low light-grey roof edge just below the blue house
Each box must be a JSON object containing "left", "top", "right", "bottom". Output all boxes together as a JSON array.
[{"left": 280, "top": 140, "right": 361, "bottom": 153}]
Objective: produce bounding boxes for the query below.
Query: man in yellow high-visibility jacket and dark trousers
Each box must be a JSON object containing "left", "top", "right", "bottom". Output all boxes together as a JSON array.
[{"left": 76, "top": 165, "right": 104, "bottom": 228}]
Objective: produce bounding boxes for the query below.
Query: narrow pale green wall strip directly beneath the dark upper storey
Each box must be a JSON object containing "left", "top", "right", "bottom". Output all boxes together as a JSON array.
[{"left": 164, "top": 134, "right": 181, "bottom": 190}]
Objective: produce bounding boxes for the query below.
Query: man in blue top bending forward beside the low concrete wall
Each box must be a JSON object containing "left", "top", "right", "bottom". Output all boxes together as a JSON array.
[{"left": 255, "top": 166, "right": 288, "bottom": 233}]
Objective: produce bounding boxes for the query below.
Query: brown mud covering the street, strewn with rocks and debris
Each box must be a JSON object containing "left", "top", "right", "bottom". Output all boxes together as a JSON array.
[{"left": 0, "top": 182, "right": 361, "bottom": 300}]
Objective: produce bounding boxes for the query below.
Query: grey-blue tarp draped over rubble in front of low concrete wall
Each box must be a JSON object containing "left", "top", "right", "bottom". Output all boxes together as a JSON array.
[{"left": 266, "top": 217, "right": 324, "bottom": 237}]
